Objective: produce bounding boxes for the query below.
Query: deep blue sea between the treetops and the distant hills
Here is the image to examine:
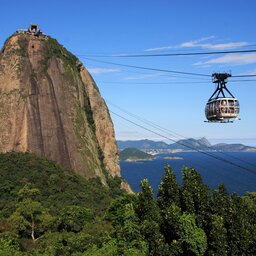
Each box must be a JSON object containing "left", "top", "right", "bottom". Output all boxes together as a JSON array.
[{"left": 120, "top": 152, "right": 256, "bottom": 195}]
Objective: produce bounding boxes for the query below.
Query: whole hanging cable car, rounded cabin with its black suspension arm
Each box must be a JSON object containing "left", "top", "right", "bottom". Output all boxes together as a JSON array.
[{"left": 205, "top": 73, "right": 240, "bottom": 123}]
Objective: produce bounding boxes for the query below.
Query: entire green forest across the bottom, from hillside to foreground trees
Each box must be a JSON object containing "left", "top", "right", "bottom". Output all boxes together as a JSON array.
[{"left": 0, "top": 152, "right": 256, "bottom": 256}]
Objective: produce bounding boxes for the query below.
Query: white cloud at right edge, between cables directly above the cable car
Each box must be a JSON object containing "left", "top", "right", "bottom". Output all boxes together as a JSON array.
[{"left": 194, "top": 53, "right": 256, "bottom": 65}]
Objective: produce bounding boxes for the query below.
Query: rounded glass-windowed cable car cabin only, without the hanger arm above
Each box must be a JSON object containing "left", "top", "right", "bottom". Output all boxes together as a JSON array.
[{"left": 205, "top": 98, "right": 240, "bottom": 122}]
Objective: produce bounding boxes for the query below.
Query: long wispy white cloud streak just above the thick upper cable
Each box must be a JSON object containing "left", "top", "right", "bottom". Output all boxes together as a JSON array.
[{"left": 145, "top": 36, "right": 251, "bottom": 51}]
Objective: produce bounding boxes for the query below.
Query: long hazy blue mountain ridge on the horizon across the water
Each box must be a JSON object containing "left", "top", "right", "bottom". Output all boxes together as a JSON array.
[{"left": 117, "top": 137, "right": 256, "bottom": 152}]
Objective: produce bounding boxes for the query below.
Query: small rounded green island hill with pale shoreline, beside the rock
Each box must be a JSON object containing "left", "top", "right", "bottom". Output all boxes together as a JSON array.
[{"left": 120, "top": 148, "right": 154, "bottom": 161}]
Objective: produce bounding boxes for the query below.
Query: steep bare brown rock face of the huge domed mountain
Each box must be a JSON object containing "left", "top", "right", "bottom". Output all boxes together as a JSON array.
[{"left": 0, "top": 30, "right": 120, "bottom": 183}]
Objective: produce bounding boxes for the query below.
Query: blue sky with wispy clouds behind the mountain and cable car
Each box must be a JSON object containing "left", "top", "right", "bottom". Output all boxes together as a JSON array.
[{"left": 0, "top": 0, "right": 256, "bottom": 146}]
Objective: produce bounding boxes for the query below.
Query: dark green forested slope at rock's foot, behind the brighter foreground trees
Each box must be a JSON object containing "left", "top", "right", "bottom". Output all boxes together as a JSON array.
[{"left": 0, "top": 152, "right": 124, "bottom": 217}]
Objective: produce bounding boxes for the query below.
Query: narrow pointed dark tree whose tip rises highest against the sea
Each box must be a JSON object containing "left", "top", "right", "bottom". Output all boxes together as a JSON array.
[{"left": 157, "top": 165, "right": 180, "bottom": 209}]
